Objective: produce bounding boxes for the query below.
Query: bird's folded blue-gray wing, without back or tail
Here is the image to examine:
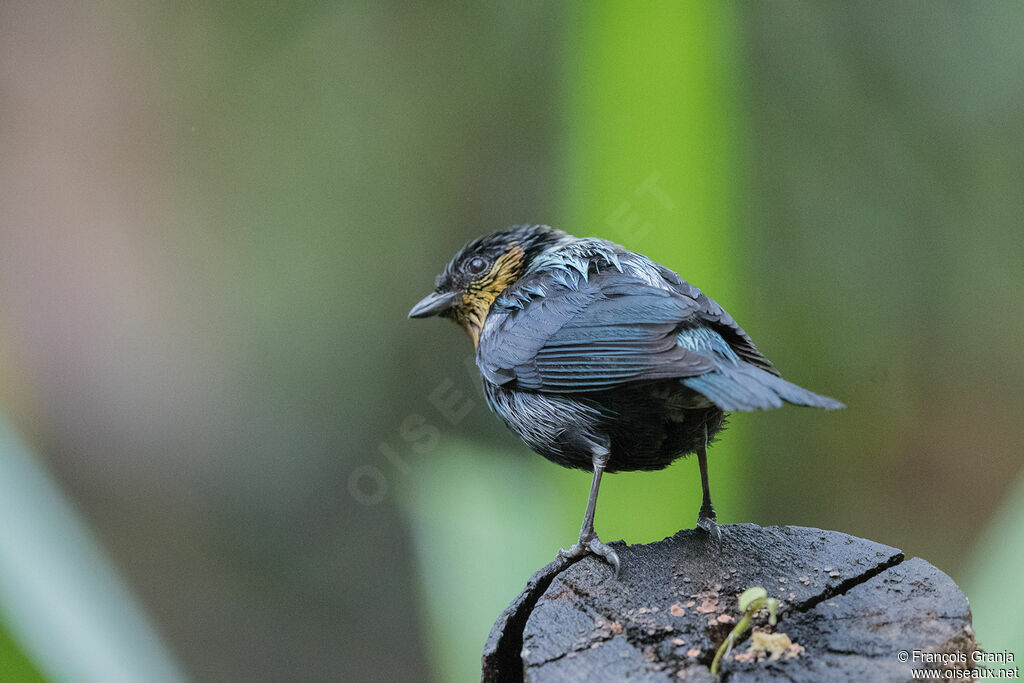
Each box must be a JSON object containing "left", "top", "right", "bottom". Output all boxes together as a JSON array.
[{"left": 477, "top": 276, "right": 715, "bottom": 392}]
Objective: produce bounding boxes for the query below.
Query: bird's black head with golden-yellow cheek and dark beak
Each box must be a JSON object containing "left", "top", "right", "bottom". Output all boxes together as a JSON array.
[{"left": 409, "top": 225, "right": 567, "bottom": 346}]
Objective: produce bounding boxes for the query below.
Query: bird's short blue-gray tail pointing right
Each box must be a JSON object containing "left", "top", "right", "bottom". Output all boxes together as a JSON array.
[{"left": 681, "top": 361, "right": 845, "bottom": 412}]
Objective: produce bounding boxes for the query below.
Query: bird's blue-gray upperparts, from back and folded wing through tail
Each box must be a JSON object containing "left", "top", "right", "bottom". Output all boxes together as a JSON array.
[{"left": 476, "top": 255, "right": 843, "bottom": 411}]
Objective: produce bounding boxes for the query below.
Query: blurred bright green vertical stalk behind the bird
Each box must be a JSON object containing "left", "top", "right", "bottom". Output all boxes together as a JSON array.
[{"left": 558, "top": 2, "right": 750, "bottom": 543}]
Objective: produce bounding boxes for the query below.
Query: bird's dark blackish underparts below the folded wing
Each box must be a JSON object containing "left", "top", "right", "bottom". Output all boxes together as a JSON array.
[{"left": 483, "top": 380, "right": 725, "bottom": 472}]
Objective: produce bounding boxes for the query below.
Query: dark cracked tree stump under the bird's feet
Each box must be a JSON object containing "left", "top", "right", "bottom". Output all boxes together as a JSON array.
[{"left": 483, "top": 524, "right": 976, "bottom": 683}]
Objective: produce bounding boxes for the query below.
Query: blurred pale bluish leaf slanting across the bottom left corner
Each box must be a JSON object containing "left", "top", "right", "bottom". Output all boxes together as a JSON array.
[{"left": 0, "top": 419, "right": 184, "bottom": 683}]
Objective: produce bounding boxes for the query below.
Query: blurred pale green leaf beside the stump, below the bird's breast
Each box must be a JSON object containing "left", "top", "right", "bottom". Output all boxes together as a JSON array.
[{"left": 400, "top": 443, "right": 590, "bottom": 681}]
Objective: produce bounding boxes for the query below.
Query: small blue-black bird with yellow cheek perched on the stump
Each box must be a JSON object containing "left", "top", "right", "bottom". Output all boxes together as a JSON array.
[{"left": 409, "top": 224, "right": 844, "bottom": 577}]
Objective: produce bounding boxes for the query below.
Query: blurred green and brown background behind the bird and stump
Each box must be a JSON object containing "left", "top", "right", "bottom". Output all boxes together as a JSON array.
[{"left": 0, "top": 0, "right": 1024, "bottom": 681}]
